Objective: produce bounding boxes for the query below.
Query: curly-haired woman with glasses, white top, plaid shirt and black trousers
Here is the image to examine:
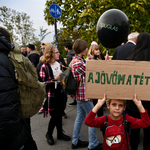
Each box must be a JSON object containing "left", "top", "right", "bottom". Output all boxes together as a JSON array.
[{"left": 40, "top": 45, "right": 71, "bottom": 145}]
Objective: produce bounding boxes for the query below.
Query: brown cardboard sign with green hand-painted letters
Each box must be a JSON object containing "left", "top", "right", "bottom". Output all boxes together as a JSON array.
[{"left": 85, "top": 60, "right": 150, "bottom": 101}]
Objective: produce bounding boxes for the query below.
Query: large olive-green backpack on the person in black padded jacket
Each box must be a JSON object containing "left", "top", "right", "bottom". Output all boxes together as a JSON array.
[{"left": 8, "top": 44, "right": 46, "bottom": 118}]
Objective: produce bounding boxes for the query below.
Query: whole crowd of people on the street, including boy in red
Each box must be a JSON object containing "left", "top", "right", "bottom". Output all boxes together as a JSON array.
[{"left": 0, "top": 27, "right": 150, "bottom": 150}]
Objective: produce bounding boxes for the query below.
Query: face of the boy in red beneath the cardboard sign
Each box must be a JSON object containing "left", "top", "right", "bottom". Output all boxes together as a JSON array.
[{"left": 107, "top": 99, "right": 126, "bottom": 120}]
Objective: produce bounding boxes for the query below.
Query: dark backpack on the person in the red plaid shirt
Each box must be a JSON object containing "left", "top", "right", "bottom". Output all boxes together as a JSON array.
[{"left": 60, "top": 59, "right": 82, "bottom": 95}]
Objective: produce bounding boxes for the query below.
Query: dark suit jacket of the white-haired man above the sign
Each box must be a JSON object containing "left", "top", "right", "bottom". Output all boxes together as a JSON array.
[{"left": 112, "top": 42, "right": 135, "bottom": 60}]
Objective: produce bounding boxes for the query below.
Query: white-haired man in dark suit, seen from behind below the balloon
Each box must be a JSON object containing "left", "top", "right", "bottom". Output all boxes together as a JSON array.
[{"left": 112, "top": 32, "right": 139, "bottom": 60}]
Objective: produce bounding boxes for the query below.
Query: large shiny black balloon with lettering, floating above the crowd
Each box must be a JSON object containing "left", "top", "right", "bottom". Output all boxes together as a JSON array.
[{"left": 96, "top": 9, "right": 130, "bottom": 48}]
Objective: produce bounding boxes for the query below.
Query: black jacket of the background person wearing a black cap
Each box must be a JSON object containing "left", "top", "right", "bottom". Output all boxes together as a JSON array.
[{"left": 28, "top": 50, "right": 40, "bottom": 67}]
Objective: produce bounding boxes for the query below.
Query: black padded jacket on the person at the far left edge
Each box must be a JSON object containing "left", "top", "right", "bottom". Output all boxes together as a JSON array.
[{"left": 0, "top": 33, "right": 26, "bottom": 150}]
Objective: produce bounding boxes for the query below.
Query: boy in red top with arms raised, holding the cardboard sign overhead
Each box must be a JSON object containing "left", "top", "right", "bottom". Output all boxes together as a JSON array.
[{"left": 85, "top": 94, "right": 150, "bottom": 150}]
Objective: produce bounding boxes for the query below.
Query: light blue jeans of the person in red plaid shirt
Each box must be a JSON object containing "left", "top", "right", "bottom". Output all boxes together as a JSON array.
[{"left": 72, "top": 100, "right": 99, "bottom": 149}]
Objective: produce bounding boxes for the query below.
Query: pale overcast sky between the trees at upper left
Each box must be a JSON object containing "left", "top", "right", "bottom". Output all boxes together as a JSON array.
[{"left": 0, "top": 0, "right": 60, "bottom": 43}]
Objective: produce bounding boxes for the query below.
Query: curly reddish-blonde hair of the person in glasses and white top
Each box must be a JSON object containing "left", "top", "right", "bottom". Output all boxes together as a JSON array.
[{"left": 43, "top": 45, "right": 56, "bottom": 63}]
